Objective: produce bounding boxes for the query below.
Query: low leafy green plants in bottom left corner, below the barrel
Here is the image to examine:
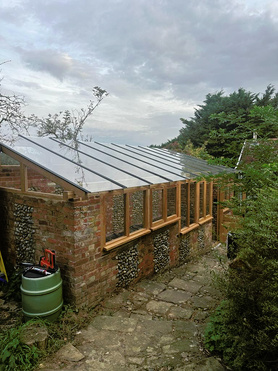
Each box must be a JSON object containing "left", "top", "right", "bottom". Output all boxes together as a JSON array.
[{"left": 0, "top": 323, "right": 43, "bottom": 371}]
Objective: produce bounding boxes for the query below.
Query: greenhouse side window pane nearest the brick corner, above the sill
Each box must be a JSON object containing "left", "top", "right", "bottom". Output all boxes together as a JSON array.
[{"left": 105, "top": 193, "right": 125, "bottom": 242}]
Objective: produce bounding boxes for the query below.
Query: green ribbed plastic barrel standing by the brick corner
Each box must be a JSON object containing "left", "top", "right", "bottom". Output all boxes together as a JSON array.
[{"left": 20, "top": 269, "right": 63, "bottom": 321}]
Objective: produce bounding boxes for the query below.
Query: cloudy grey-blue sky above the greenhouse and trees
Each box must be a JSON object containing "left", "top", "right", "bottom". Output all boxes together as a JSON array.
[{"left": 0, "top": 0, "right": 278, "bottom": 145}]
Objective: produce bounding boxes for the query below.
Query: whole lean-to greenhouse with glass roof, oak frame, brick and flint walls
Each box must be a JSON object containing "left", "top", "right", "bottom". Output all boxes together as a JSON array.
[{"left": 0, "top": 136, "right": 233, "bottom": 306}]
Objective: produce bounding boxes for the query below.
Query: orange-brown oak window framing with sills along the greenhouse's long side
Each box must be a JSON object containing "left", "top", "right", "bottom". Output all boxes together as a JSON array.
[{"left": 100, "top": 180, "right": 213, "bottom": 252}]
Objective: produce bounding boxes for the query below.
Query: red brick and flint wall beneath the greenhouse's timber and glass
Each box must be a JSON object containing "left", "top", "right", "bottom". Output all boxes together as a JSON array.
[{"left": 0, "top": 190, "right": 212, "bottom": 307}]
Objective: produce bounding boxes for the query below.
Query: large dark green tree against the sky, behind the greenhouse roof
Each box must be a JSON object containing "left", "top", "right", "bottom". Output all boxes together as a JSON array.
[{"left": 177, "top": 85, "right": 278, "bottom": 166}]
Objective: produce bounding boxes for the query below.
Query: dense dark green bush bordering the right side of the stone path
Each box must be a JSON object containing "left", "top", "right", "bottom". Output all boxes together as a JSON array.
[{"left": 205, "top": 189, "right": 278, "bottom": 370}]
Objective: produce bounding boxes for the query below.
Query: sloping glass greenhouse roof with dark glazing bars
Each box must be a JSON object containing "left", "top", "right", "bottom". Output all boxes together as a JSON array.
[{"left": 0, "top": 135, "right": 234, "bottom": 193}]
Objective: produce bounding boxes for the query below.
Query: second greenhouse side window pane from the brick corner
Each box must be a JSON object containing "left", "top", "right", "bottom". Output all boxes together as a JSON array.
[{"left": 129, "top": 191, "right": 145, "bottom": 233}]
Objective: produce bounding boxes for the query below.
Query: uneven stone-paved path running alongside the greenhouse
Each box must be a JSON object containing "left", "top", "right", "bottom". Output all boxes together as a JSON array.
[{"left": 40, "top": 245, "right": 225, "bottom": 371}]
